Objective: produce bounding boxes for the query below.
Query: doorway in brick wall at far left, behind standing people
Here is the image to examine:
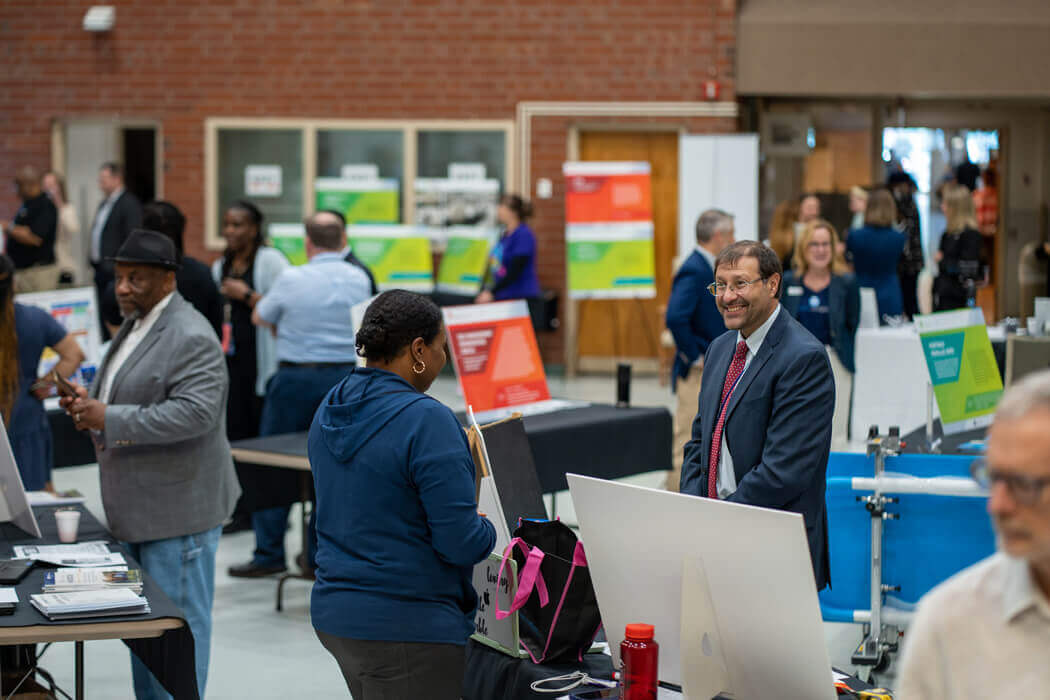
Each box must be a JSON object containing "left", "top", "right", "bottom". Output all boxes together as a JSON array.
[{"left": 51, "top": 119, "right": 163, "bottom": 284}]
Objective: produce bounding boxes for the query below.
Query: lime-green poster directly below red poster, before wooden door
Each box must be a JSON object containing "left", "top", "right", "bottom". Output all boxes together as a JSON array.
[{"left": 566, "top": 221, "right": 656, "bottom": 299}]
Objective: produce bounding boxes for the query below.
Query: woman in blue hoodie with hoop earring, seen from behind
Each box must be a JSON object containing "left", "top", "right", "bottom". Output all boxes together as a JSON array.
[{"left": 309, "top": 290, "right": 496, "bottom": 700}]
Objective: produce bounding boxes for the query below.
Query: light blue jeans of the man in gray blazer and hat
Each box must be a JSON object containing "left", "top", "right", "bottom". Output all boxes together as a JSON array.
[{"left": 124, "top": 526, "right": 223, "bottom": 700}]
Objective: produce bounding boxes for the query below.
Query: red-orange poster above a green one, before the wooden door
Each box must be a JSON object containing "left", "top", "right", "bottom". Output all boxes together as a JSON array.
[{"left": 563, "top": 162, "right": 653, "bottom": 224}]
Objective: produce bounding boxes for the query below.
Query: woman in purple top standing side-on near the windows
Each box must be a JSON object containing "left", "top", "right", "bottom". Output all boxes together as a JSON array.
[{"left": 475, "top": 194, "right": 540, "bottom": 303}]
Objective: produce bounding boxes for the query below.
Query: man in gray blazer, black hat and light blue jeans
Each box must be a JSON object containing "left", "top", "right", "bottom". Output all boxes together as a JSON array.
[{"left": 62, "top": 230, "right": 240, "bottom": 699}]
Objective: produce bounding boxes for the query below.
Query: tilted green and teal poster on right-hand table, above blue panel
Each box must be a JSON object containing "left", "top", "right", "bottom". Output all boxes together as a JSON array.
[{"left": 916, "top": 309, "right": 1003, "bottom": 434}]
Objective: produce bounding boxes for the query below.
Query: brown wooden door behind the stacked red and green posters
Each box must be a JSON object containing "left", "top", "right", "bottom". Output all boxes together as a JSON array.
[{"left": 576, "top": 131, "right": 678, "bottom": 370}]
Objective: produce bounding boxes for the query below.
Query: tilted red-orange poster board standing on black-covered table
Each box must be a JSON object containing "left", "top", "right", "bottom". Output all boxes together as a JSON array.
[{"left": 442, "top": 300, "right": 550, "bottom": 420}]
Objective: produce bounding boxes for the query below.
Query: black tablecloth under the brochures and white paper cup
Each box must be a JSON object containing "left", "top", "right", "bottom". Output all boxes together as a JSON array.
[{"left": 0, "top": 507, "right": 198, "bottom": 700}]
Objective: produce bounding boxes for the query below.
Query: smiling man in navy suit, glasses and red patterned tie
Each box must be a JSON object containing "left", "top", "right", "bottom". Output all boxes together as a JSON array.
[{"left": 681, "top": 240, "right": 835, "bottom": 591}]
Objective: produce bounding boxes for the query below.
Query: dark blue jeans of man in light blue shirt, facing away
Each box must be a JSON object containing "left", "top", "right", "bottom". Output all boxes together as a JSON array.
[{"left": 252, "top": 363, "right": 354, "bottom": 567}]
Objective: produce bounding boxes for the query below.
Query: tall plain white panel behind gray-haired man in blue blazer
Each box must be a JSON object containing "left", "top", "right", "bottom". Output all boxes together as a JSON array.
[{"left": 678, "top": 133, "right": 759, "bottom": 261}]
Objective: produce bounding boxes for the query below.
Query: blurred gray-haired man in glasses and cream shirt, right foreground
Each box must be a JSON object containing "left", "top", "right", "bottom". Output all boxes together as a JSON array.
[{"left": 897, "top": 370, "right": 1050, "bottom": 700}]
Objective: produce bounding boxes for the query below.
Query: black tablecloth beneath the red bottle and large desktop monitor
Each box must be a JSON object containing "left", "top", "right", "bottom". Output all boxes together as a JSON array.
[{"left": 463, "top": 639, "right": 873, "bottom": 700}]
